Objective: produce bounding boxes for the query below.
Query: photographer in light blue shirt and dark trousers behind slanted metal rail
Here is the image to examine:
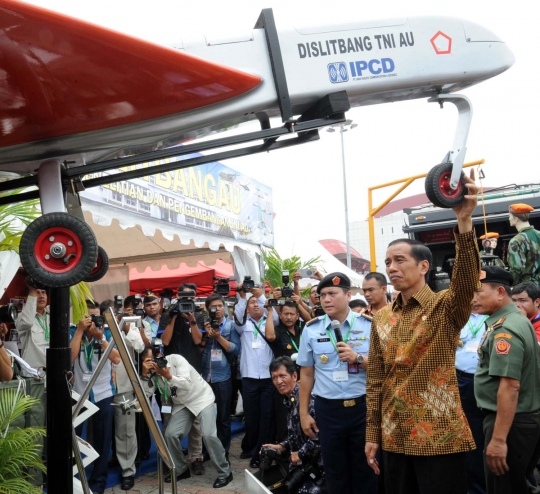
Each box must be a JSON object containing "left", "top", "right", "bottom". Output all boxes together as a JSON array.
[{"left": 70, "top": 300, "right": 121, "bottom": 494}]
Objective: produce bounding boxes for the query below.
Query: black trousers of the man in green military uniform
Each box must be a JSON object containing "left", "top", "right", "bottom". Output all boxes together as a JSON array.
[{"left": 484, "top": 412, "right": 540, "bottom": 494}]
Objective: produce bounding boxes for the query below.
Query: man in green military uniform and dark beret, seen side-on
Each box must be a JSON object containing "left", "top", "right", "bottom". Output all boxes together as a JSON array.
[{"left": 474, "top": 266, "right": 540, "bottom": 494}]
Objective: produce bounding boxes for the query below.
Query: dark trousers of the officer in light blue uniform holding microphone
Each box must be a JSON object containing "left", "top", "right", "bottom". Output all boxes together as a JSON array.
[{"left": 315, "top": 397, "right": 377, "bottom": 494}]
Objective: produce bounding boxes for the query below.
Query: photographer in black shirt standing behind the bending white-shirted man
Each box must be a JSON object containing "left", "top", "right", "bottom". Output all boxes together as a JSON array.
[{"left": 156, "top": 283, "right": 204, "bottom": 475}]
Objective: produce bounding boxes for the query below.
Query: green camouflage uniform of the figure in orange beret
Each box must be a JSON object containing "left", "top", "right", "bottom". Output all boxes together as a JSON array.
[{"left": 508, "top": 226, "right": 540, "bottom": 286}]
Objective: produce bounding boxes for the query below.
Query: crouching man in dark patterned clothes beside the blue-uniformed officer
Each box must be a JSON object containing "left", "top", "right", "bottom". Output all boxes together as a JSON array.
[{"left": 261, "top": 357, "right": 327, "bottom": 494}]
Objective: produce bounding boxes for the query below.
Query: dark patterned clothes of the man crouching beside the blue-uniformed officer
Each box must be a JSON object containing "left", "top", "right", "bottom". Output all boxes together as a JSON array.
[{"left": 281, "top": 384, "right": 327, "bottom": 494}]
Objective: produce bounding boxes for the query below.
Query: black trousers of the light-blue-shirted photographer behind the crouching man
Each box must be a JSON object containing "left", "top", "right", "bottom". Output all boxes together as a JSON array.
[{"left": 242, "top": 377, "right": 275, "bottom": 461}]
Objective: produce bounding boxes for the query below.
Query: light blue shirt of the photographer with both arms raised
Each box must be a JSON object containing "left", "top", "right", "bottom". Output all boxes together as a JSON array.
[{"left": 234, "top": 295, "right": 279, "bottom": 379}]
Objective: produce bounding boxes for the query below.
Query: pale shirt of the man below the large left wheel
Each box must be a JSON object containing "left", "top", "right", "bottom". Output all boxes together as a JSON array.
[{"left": 15, "top": 295, "right": 51, "bottom": 369}]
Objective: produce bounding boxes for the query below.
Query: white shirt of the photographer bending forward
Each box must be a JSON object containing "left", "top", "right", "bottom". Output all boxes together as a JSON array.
[{"left": 147, "top": 355, "right": 215, "bottom": 416}]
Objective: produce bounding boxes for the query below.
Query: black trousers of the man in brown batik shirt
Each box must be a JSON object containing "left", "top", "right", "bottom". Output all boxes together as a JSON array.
[{"left": 382, "top": 450, "right": 468, "bottom": 494}]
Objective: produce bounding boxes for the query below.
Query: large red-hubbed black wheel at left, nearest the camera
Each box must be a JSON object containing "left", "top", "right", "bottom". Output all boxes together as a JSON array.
[{"left": 19, "top": 213, "right": 98, "bottom": 288}]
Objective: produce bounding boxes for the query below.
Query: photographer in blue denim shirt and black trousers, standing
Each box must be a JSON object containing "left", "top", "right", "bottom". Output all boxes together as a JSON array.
[{"left": 202, "top": 294, "right": 240, "bottom": 457}]
